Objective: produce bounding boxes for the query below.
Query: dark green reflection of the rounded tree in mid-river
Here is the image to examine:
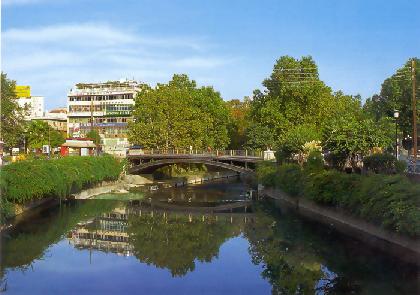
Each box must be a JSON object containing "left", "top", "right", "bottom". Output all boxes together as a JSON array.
[{"left": 127, "top": 214, "right": 240, "bottom": 277}]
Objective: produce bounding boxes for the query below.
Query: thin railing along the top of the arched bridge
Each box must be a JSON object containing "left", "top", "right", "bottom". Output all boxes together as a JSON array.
[{"left": 129, "top": 149, "right": 264, "bottom": 158}]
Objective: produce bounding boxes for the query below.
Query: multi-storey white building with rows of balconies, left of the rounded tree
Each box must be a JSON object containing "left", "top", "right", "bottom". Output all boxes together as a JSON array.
[{"left": 67, "top": 80, "right": 140, "bottom": 155}]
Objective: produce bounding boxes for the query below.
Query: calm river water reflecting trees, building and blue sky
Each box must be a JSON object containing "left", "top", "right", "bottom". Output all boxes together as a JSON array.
[{"left": 0, "top": 182, "right": 419, "bottom": 294}]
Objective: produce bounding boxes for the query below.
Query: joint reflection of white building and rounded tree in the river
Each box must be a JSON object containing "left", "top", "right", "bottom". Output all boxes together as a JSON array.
[{"left": 68, "top": 202, "right": 253, "bottom": 276}]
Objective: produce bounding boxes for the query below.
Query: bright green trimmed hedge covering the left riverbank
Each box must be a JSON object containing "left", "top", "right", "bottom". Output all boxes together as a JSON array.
[{"left": 0, "top": 156, "right": 122, "bottom": 219}]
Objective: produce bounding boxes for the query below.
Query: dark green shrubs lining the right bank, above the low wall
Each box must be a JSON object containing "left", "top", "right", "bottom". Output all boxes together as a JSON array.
[{"left": 257, "top": 163, "right": 420, "bottom": 237}]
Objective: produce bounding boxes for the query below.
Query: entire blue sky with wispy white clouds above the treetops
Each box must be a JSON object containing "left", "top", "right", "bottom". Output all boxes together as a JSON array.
[{"left": 1, "top": 0, "right": 420, "bottom": 108}]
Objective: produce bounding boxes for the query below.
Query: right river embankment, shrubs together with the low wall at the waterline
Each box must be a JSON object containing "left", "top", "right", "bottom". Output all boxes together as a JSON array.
[{"left": 257, "top": 162, "right": 420, "bottom": 263}]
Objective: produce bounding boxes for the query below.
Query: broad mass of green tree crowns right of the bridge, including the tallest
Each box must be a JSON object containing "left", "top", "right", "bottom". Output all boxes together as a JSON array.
[{"left": 247, "top": 56, "right": 393, "bottom": 166}]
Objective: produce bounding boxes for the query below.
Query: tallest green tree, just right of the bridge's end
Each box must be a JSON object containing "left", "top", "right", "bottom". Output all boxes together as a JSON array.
[{"left": 247, "top": 56, "right": 335, "bottom": 146}]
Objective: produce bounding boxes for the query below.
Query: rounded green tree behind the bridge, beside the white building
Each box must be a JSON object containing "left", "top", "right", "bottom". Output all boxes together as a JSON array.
[{"left": 129, "top": 75, "right": 230, "bottom": 149}]
